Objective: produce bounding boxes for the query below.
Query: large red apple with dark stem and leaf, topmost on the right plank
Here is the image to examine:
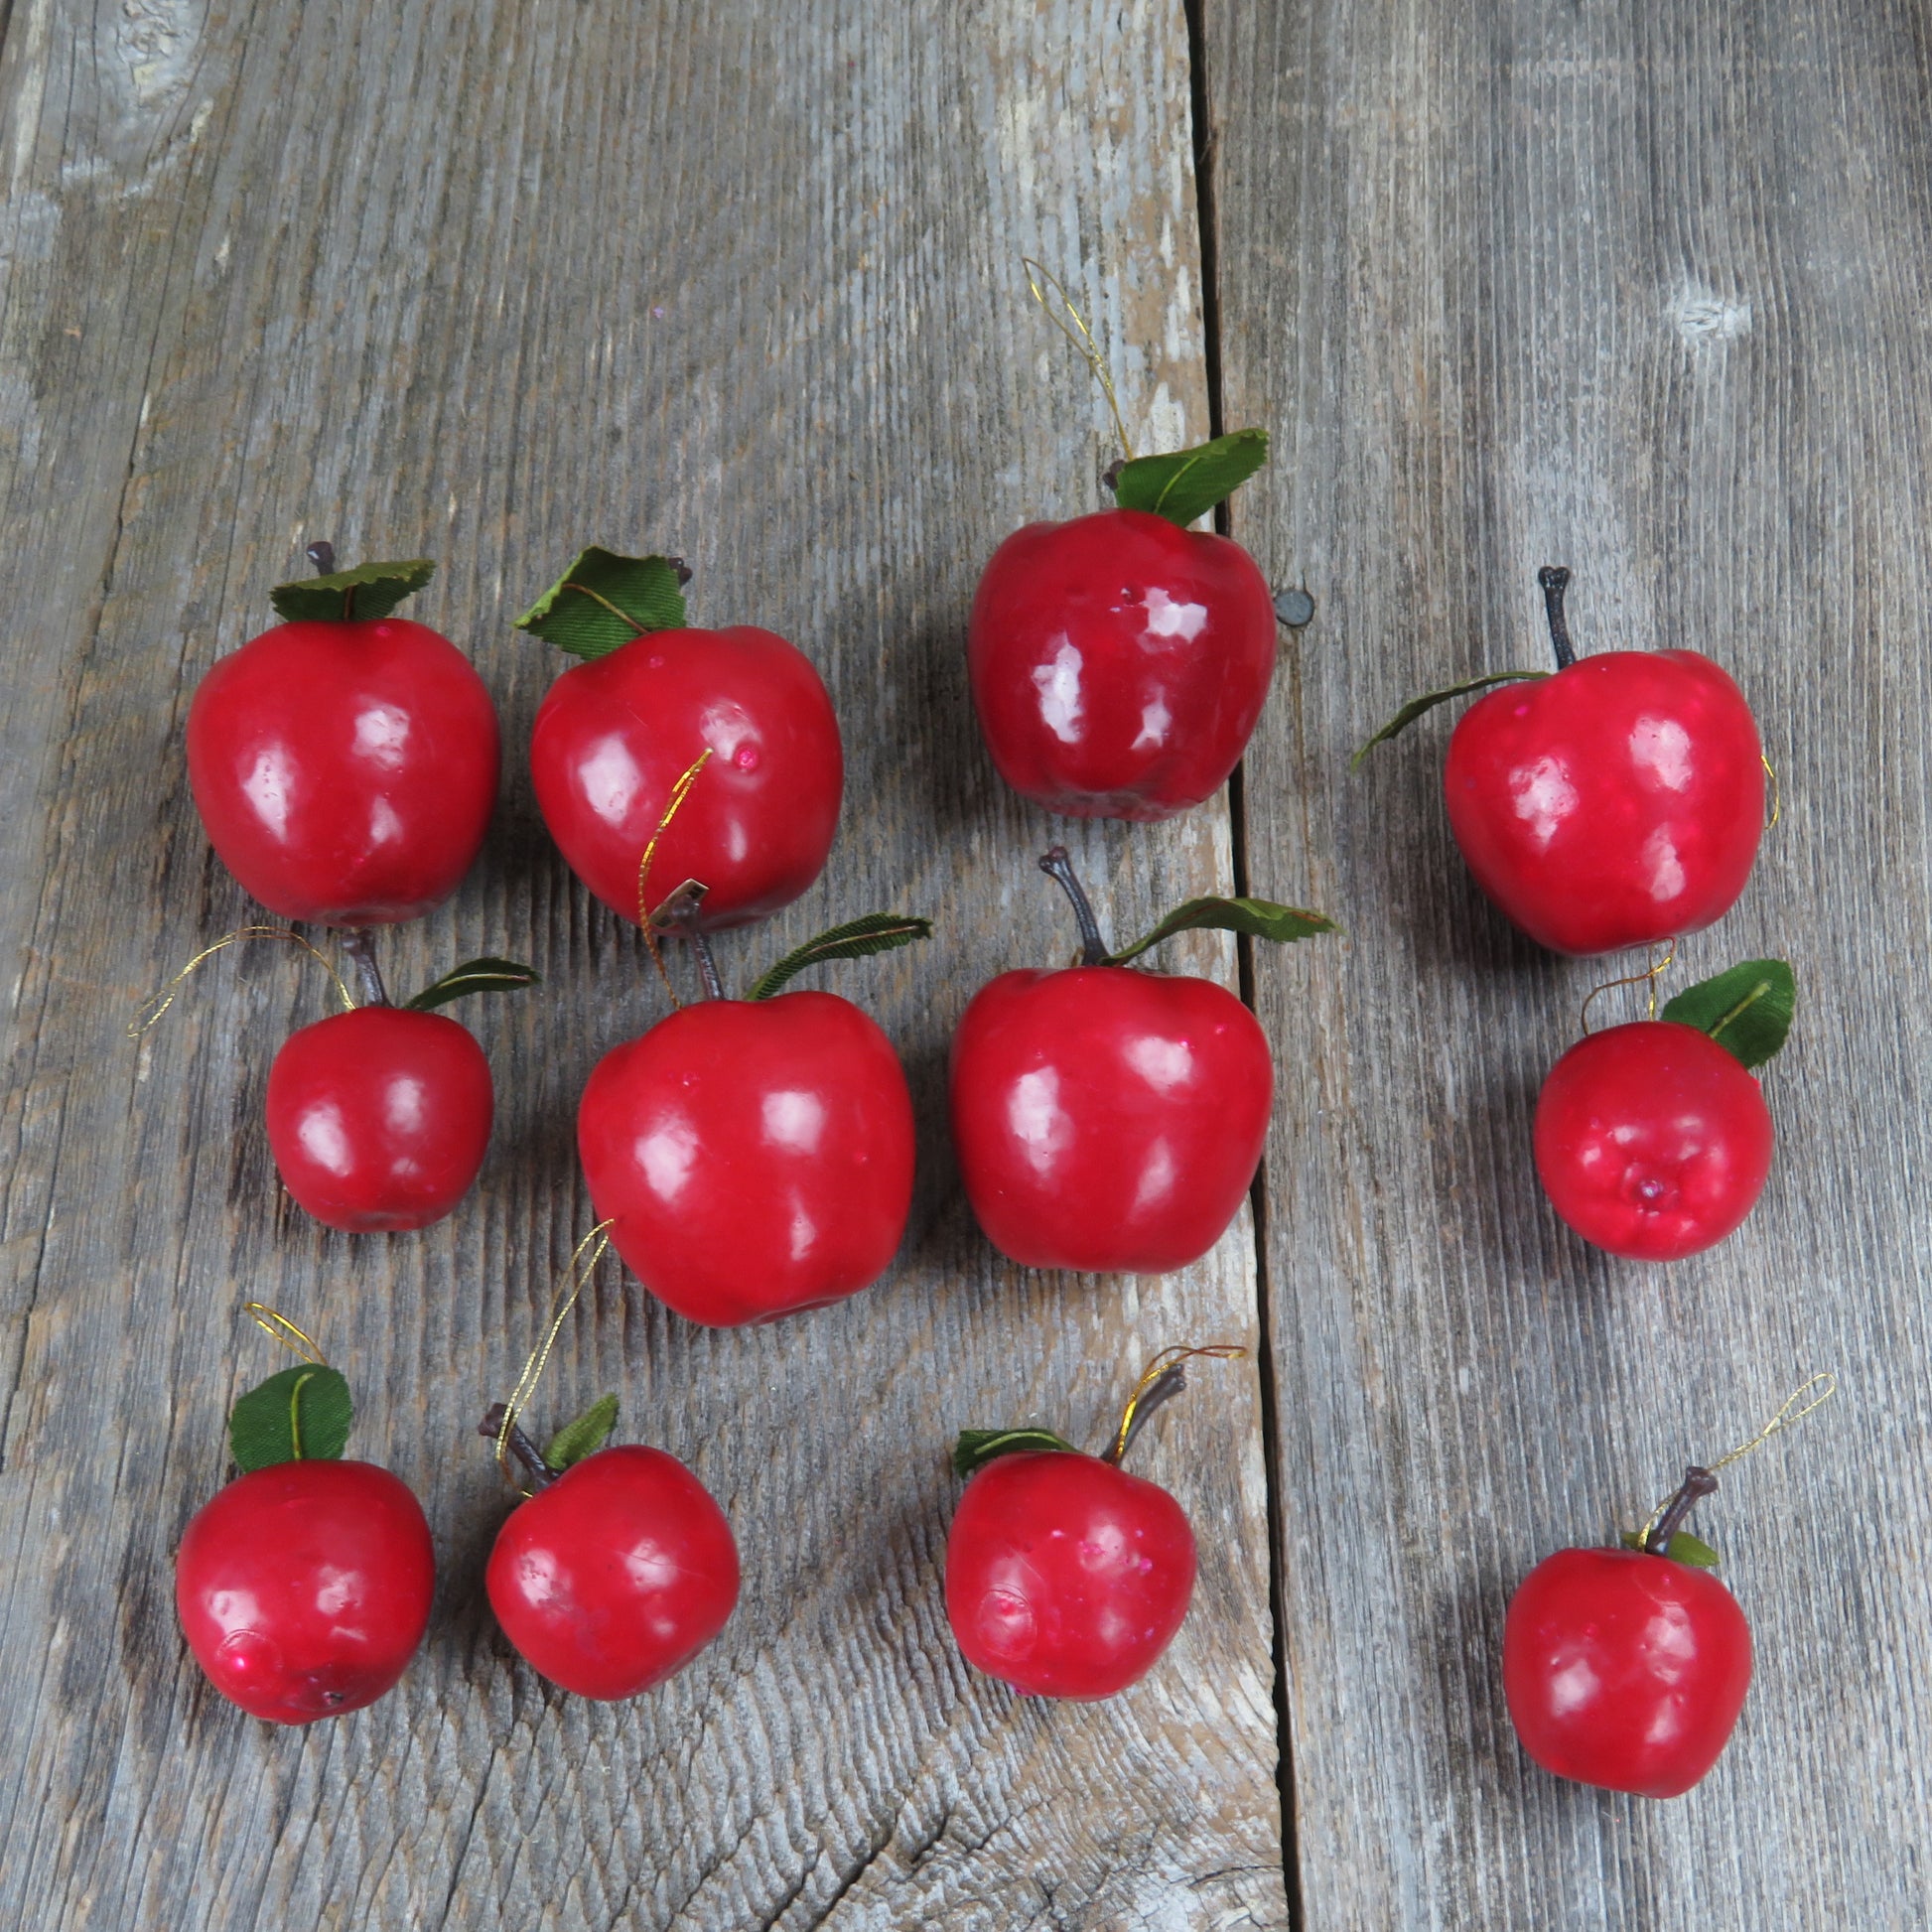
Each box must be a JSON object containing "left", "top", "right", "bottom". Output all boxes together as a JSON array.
[{"left": 1356, "top": 566, "right": 1766, "bottom": 954}]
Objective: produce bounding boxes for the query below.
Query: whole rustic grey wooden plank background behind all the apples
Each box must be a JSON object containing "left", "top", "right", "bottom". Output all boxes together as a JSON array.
[{"left": 0, "top": 0, "right": 1932, "bottom": 1932}]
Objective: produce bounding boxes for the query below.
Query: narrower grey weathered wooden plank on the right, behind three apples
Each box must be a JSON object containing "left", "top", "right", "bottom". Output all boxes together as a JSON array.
[{"left": 1209, "top": 0, "right": 1932, "bottom": 1932}]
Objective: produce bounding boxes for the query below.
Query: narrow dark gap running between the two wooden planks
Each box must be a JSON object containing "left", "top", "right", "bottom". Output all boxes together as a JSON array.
[{"left": 1184, "top": 0, "right": 1306, "bottom": 1932}]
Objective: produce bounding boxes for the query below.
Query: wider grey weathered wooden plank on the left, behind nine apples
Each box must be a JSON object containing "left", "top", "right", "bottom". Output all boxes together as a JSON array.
[{"left": 0, "top": 0, "right": 1301, "bottom": 1932}]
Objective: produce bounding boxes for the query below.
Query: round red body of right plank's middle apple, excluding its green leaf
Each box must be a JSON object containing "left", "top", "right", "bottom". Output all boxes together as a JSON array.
[{"left": 1536, "top": 1020, "right": 1773, "bottom": 1262}]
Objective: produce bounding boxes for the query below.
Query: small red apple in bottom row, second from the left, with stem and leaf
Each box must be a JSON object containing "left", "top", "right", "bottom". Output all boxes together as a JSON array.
[{"left": 482, "top": 1395, "right": 738, "bottom": 1700}]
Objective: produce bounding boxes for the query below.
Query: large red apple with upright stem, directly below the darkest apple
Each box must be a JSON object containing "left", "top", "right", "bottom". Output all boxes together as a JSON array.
[{"left": 950, "top": 846, "right": 1335, "bottom": 1275}]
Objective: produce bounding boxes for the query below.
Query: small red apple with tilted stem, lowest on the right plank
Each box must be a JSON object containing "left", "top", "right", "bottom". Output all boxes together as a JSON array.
[{"left": 1503, "top": 1470, "right": 1750, "bottom": 1799}]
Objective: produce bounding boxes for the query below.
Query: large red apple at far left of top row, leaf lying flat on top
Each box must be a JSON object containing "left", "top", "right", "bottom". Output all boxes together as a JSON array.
[{"left": 188, "top": 545, "right": 498, "bottom": 925}]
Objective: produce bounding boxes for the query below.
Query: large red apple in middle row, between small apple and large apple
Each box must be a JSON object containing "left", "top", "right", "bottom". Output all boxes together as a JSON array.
[{"left": 578, "top": 913, "right": 931, "bottom": 1327}]
